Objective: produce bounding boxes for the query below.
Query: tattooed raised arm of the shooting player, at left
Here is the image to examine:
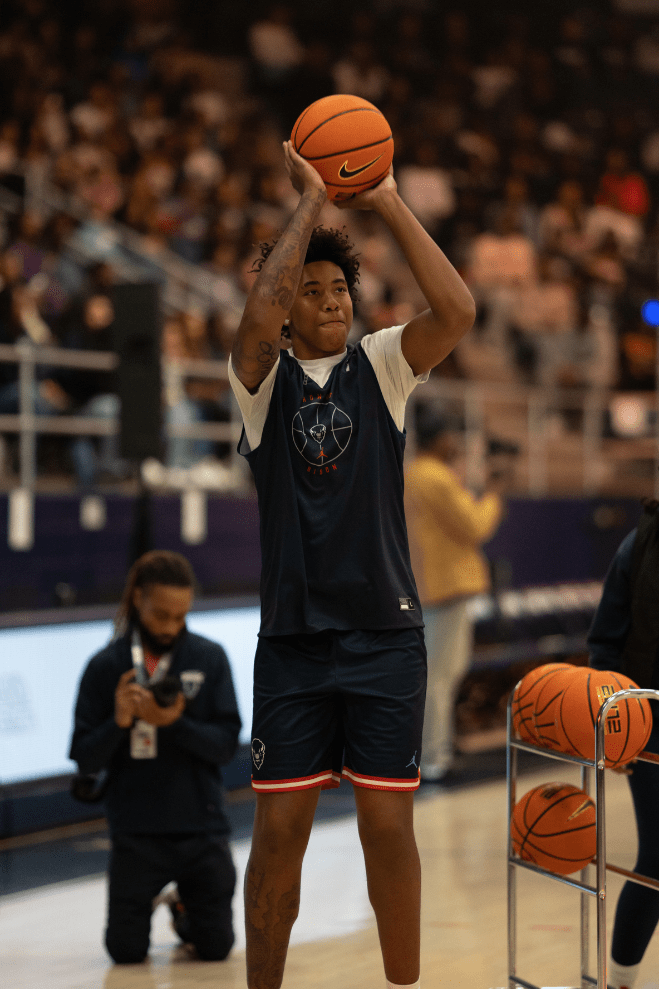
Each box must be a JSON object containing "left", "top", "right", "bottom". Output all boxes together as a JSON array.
[{"left": 231, "top": 141, "right": 327, "bottom": 392}]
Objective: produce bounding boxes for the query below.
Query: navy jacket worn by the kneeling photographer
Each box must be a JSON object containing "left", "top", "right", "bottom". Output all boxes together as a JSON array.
[{"left": 69, "top": 630, "right": 241, "bottom": 834}]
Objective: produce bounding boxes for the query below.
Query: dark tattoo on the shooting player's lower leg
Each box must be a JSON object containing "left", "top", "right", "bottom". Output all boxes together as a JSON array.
[{"left": 245, "top": 864, "right": 300, "bottom": 989}]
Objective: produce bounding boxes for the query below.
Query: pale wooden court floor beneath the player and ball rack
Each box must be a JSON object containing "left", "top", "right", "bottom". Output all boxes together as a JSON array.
[{"left": 0, "top": 760, "right": 659, "bottom": 989}]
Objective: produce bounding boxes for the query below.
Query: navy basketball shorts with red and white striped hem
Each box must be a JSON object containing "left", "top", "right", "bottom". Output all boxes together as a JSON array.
[{"left": 252, "top": 628, "right": 427, "bottom": 793}]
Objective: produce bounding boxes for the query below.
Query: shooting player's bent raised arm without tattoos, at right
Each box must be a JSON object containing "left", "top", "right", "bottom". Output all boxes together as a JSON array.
[{"left": 335, "top": 169, "right": 476, "bottom": 374}]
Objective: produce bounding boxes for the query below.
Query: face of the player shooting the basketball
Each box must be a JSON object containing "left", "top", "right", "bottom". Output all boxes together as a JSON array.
[{"left": 289, "top": 261, "right": 352, "bottom": 361}]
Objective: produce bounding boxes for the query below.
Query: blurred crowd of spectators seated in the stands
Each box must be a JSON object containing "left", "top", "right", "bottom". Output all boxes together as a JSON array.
[{"left": 0, "top": 0, "right": 659, "bottom": 484}]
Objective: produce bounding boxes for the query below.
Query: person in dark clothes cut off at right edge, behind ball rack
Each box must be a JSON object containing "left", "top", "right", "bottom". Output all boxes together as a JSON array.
[{"left": 588, "top": 502, "right": 659, "bottom": 989}]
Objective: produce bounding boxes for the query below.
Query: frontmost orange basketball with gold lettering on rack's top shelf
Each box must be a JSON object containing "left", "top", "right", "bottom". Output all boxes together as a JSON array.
[{"left": 556, "top": 669, "right": 652, "bottom": 768}]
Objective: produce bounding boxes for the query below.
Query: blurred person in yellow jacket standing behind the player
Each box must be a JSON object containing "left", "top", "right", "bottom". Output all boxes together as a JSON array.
[{"left": 405, "top": 410, "right": 503, "bottom": 782}]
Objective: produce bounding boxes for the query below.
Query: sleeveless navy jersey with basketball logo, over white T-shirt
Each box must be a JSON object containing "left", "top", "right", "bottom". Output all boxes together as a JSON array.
[{"left": 240, "top": 345, "right": 423, "bottom": 636}]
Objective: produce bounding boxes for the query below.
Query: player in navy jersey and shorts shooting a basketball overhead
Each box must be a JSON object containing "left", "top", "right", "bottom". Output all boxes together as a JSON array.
[{"left": 229, "top": 142, "right": 474, "bottom": 989}]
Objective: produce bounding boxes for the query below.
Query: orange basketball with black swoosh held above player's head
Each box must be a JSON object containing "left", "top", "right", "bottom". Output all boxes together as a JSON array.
[{"left": 291, "top": 93, "right": 394, "bottom": 200}]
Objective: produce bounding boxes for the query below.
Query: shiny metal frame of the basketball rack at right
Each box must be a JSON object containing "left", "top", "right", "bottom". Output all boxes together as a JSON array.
[{"left": 506, "top": 689, "right": 659, "bottom": 989}]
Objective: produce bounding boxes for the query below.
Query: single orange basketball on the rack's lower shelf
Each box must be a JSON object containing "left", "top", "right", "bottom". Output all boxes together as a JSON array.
[{"left": 510, "top": 783, "right": 597, "bottom": 876}]
